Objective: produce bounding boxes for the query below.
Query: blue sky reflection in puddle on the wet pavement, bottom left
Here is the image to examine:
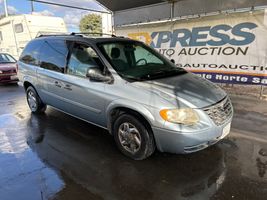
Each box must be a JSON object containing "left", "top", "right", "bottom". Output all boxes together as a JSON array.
[{"left": 0, "top": 112, "right": 64, "bottom": 200}]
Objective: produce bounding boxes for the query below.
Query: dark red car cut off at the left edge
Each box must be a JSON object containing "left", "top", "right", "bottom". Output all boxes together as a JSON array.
[{"left": 0, "top": 53, "right": 19, "bottom": 83}]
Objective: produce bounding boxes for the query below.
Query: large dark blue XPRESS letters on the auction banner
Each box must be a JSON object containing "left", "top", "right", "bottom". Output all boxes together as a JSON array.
[{"left": 150, "top": 22, "right": 258, "bottom": 48}]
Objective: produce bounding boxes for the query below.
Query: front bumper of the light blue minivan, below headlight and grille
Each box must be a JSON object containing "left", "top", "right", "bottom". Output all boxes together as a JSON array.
[{"left": 152, "top": 117, "right": 232, "bottom": 154}]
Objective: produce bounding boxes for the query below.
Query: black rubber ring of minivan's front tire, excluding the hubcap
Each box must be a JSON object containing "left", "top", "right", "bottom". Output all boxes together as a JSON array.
[{"left": 113, "top": 114, "right": 154, "bottom": 160}]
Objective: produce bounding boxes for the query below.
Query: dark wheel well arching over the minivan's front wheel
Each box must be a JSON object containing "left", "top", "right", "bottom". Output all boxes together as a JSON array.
[{"left": 108, "top": 107, "right": 154, "bottom": 136}]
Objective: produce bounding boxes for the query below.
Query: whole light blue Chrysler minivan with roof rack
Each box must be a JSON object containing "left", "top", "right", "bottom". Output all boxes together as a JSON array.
[{"left": 18, "top": 34, "right": 233, "bottom": 160}]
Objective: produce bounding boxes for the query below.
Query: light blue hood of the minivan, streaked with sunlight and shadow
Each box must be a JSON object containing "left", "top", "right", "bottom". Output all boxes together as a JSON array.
[{"left": 133, "top": 73, "right": 227, "bottom": 108}]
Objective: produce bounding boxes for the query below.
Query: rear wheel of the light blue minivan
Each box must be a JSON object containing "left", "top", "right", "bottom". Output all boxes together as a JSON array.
[{"left": 26, "top": 86, "right": 46, "bottom": 114}]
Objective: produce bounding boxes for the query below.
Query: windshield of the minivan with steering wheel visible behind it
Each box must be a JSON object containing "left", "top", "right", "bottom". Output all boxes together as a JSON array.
[{"left": 99, "top": 41, "right": 186, "bottom": 81}]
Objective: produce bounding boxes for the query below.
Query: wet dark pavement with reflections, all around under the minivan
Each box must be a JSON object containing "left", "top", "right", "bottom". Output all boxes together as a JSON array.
[{"left": 0, "top": 86, "right": 267, "bottom": 200}]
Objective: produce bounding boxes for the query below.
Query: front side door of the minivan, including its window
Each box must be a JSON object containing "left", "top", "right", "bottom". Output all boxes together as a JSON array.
[{"left": 59, "top": 42, "right": 106, "bottom": 126}]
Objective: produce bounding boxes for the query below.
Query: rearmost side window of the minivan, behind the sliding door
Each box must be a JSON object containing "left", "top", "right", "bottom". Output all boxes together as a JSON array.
[{"left": 19, "top": 40, "right": 43, "bottom": 66}]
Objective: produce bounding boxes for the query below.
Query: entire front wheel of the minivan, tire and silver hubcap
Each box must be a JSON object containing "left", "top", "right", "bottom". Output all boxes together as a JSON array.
[{"left": 113, "top": 114, "right": 155, "bottom": 160}]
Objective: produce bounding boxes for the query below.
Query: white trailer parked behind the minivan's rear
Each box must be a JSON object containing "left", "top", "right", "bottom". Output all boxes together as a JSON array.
[{"left": 0, "top": 14, "right": 67, "bottom": 58}]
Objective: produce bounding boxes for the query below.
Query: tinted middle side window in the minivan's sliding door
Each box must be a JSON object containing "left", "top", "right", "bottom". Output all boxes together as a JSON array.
[{"left": 40, "top": 39, "right": 68, "bottom": 73}]
